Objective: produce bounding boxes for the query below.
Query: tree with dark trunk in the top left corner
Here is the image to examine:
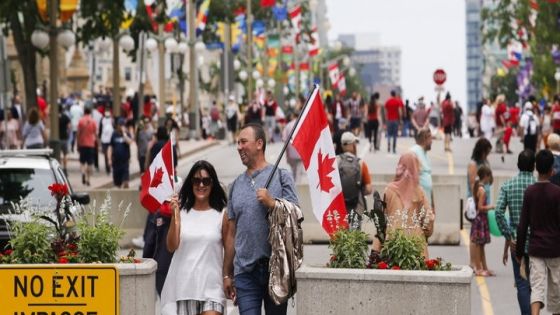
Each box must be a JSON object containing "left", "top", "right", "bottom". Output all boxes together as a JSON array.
[{"left": 0, "top": 0, "right": 43, "bottom": 108}]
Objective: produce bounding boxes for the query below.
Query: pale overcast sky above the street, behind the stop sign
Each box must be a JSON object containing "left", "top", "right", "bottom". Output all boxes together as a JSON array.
[{"left": 326, "top": 0, "right": 467, "bottom": 106}]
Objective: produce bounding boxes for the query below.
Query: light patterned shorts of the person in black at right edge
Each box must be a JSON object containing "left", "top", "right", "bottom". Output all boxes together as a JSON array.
[{"left": 529, "top": 256, "right": 560, "bottom": 313}]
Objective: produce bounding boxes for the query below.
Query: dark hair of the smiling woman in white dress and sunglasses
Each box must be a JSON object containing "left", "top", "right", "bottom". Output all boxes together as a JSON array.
[{"left": 179, "top": 160, "right": 227, "bottom": 212}]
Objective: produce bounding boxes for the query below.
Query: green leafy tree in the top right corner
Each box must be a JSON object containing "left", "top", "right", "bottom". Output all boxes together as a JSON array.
[{"left": 482, "top": 0, "right": 560, "bottom": 96}]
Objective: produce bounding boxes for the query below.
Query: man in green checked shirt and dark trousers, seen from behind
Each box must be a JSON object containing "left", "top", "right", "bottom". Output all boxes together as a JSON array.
[{"left": 496, "top": 150, "right": 535, "bottom": 315}]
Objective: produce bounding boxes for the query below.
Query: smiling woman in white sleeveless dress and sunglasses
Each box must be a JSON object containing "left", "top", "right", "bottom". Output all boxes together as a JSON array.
[{"left": 161, "top": 161, "right": 227, "bottom": 315}]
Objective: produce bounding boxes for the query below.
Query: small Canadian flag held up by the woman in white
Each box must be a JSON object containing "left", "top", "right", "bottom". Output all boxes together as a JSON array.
[{"left": 140, "top": 141, "right": 174, "bottom": 213}]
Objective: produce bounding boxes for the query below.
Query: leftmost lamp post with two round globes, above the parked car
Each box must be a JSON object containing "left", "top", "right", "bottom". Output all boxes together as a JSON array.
[{"left": 31, "top": 0, "right": 76, "bottom": 160}]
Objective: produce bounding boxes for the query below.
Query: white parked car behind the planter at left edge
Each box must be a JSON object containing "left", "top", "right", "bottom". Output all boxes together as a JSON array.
[{"left": 0, "top": 149, "right": 89, "bottom": 250}]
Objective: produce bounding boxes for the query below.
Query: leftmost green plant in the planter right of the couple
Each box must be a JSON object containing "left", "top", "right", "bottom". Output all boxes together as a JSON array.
[{"left": 328, "top": 229, "right": 368, "bottom": 268}]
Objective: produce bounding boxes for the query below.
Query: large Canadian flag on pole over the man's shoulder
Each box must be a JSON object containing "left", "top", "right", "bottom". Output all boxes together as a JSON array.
[{"left": 291, "top": 86, "right": 348, "bottom": 235}]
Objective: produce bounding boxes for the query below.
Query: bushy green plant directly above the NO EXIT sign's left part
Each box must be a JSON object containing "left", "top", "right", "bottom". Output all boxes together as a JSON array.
[{"left": 6, "top": 220, "right": 55, "bottom": 264}]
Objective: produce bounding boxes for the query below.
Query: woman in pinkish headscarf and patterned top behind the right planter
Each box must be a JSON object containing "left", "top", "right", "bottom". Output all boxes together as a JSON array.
[{"left": 374, "top": 152, "right": 435, "bottom": 259}]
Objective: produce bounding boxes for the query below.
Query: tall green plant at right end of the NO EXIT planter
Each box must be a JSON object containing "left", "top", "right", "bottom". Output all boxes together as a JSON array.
[{"left": 78, "top": 195, "right": 130, "bottom": 263}]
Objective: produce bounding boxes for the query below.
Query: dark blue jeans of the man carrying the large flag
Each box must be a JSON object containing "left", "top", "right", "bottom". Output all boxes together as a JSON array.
[{"left": 235, "top": 259, "right": 288, "bottom": 315}]
